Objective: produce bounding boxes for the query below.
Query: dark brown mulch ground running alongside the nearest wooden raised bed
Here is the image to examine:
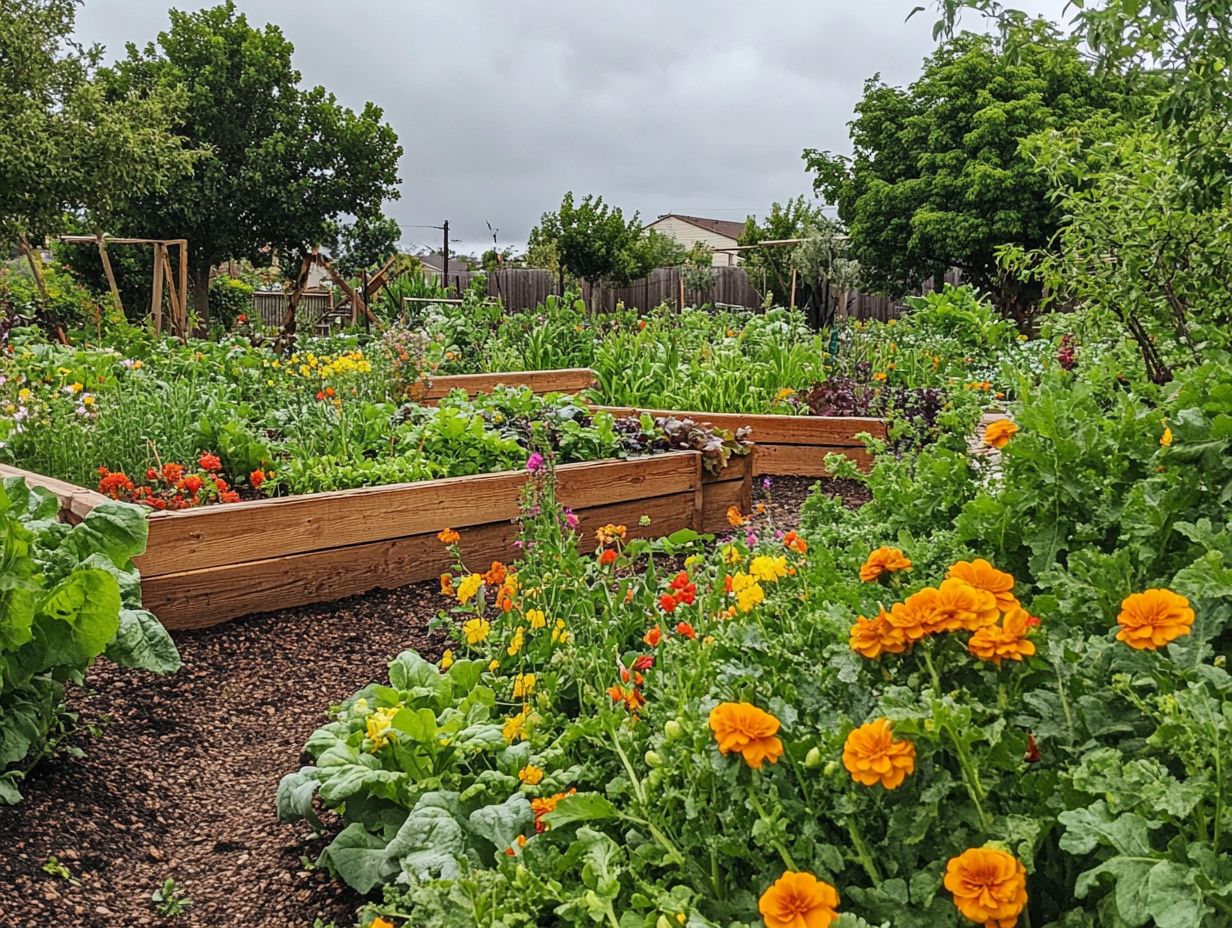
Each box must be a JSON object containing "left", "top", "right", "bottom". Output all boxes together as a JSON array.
[{"left": 0, "top": 477, "right": 862, "bottom": 928}]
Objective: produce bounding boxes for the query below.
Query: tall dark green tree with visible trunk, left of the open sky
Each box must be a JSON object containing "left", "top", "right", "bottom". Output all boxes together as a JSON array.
[{"left": 105, "top": 0, "right": 402, "bottom": 320}]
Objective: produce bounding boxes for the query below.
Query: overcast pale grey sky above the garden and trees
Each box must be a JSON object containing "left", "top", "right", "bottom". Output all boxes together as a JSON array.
[{"left": 78, "top": 0, "right": 1064, "bottom": 250}]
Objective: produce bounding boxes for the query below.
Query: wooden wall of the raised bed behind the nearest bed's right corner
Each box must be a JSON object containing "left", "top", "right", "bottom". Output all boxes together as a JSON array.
[{"left": 593, "top": 405, "right": 886, "bottom": 477}]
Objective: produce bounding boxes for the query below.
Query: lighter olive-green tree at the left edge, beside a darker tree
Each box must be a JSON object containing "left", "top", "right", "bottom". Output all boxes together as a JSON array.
[{"left": 0, "top": 0, "right": 193, "bottom": 276}]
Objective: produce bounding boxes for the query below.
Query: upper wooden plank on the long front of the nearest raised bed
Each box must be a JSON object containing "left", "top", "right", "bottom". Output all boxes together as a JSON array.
[{"left": 137, "top": 451, "right": 697, "bottom": 577}]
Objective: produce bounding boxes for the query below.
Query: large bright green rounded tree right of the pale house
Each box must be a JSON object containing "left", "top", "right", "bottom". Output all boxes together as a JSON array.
[{"left": 804, "top": 21, "right": 1122, "bottom": 314}]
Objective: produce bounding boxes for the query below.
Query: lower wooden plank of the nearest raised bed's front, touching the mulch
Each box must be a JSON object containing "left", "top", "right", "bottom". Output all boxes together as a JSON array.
[{"left": 142, "top": 489, "right": 694, "bottom": 629}]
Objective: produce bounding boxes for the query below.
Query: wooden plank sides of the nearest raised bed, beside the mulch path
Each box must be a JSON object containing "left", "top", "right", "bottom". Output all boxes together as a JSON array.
[{"left": 4, "top": 451, "right": 753, "bottom": 629}]
